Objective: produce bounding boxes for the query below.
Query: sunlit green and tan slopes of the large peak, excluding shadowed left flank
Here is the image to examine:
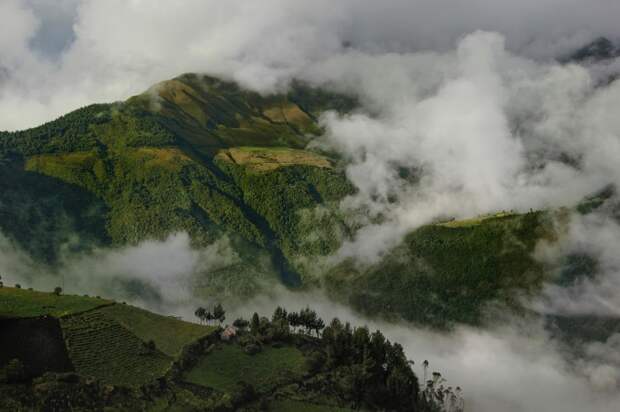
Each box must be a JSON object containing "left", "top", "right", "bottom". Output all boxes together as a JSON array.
[{"left": 0, "top": 75, "right": 353, "bottom": 285}]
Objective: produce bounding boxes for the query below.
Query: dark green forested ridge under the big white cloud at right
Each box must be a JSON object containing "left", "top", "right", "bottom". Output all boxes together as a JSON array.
[{"left": 326, "top": 212, "right": 552, "bottom": 328}]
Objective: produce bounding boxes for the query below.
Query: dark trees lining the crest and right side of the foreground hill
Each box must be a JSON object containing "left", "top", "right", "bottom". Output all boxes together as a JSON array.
[{"left": 206, "top": 307, "right": 463, "bottom": 412}]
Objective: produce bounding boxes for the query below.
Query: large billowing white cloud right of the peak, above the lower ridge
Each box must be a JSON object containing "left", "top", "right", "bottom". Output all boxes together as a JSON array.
[{"left": 305, "top": 31, "right": 620, "bottom": 260}]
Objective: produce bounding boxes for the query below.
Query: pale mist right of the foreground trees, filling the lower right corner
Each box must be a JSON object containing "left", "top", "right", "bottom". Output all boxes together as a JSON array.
[{"left": 232, "top": 288, "right": 620, "bottom": 412}]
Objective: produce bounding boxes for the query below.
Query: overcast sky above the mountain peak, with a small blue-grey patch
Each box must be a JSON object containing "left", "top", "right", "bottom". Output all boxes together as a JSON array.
[{"left": 0, "top": 0, "right": 620, "bottom": 130}]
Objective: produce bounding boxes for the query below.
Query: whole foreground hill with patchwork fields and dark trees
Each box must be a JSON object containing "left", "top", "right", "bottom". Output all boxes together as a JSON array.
[{"left": 0, "top": 287, "right": 450, "bottom": 412}]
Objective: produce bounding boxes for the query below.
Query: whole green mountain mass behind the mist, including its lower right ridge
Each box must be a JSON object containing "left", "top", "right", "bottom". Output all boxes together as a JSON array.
[{"left": 0, "top": 70, "right": 604, "bottom": 328}]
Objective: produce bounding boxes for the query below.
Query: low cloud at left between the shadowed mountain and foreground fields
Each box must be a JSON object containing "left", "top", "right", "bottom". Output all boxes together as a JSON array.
[{"left": 0, "top": 233, "right": 277, "bottom": 319}]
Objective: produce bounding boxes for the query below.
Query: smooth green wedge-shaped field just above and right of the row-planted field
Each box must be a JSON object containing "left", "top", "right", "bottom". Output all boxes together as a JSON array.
[{"left": 101, "top": 304, "right": 215, "bottom": 356}]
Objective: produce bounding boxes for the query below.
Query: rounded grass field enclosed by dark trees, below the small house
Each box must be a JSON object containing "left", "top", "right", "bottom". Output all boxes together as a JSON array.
[{"left": 185, "top": 344, "right": 304, "bottom": 392}]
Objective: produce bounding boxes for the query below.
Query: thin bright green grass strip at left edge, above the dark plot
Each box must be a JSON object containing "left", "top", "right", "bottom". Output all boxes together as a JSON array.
[{"left": 0, "top": 286, "right": 113, "bottom": 318}]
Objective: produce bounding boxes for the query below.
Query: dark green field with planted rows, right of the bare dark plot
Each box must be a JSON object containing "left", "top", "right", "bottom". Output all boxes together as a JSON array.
[{"left": 61, "top": 311, "right": 172, "bottom": 386}]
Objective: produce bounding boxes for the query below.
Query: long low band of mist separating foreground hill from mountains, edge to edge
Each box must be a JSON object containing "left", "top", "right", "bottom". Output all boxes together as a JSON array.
[{"left": 0, "top": 222, "right": 620, "bottom": 412}]
